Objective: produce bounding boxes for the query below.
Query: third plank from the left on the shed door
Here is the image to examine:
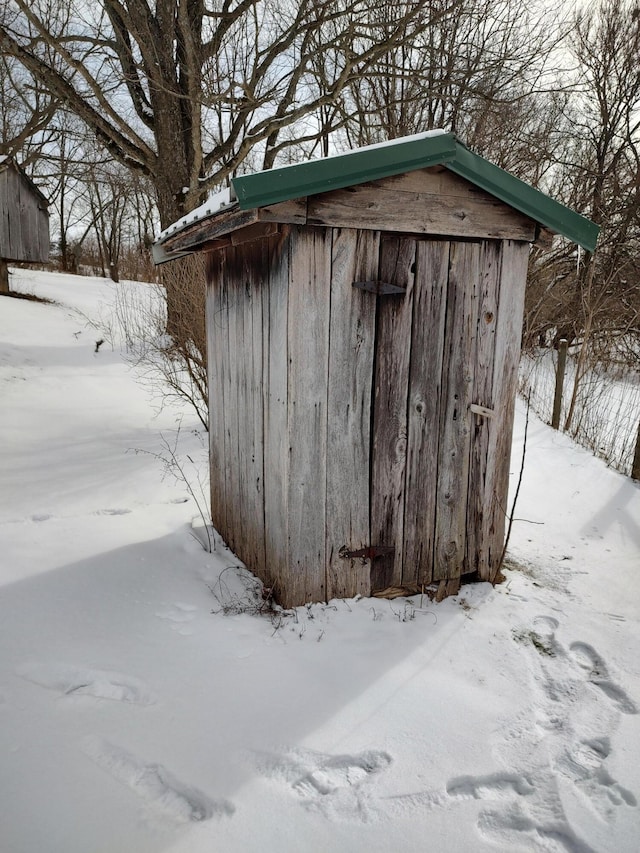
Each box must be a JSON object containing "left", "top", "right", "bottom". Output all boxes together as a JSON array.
[{"left": 433, "top": 243, "right": 481, "bottom": 580}]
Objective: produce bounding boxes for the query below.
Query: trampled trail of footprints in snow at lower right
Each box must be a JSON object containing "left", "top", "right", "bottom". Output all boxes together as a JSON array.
[{"left": 388, "top": 615, "right": 638, "bottom": 853}]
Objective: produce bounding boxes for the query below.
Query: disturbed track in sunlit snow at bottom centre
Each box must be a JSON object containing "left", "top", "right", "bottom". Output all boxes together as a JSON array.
[{"left": 258, "top": 749, "right": 392, "bottom": 820}]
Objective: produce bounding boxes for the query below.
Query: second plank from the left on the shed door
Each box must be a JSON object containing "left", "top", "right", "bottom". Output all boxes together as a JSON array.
[{"left": 402, "top": 241, "right": 449, "bottom": 585}]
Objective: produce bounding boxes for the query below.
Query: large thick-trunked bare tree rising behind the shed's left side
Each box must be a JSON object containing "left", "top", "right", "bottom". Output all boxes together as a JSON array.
[{"left": 0, "top": 0, "right": 450, "bottom": 227}]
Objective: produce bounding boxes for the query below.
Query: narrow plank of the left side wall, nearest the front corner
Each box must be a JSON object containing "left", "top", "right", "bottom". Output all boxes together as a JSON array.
[{"left": 262, "top": 233, "right": 295, "bottom": 603}]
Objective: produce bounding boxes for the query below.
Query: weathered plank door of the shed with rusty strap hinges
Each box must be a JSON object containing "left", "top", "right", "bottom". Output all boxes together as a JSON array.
[{"left": 370, "top": 236, "right": 501, "bottom": 590}]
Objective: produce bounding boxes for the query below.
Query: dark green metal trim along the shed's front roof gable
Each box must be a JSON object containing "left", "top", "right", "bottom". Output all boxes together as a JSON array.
[{"left": 232, "top": 131, "right": 600, "bottom": 252}]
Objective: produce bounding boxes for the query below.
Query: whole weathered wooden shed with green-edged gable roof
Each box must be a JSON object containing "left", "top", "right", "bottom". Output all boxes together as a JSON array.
[{"left": 155, "top": 131, "right": 598, "bottom": 607}]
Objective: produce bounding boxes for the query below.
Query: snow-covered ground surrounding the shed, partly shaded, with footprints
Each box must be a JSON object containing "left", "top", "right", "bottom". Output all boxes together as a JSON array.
[{"left": 0, "top": 271, "right": 640, "bottom": 853}]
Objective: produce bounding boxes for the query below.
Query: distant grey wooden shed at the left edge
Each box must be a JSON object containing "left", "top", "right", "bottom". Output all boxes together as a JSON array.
[{"left": 0, "top": 156, "right": 49, "bottom": 291}]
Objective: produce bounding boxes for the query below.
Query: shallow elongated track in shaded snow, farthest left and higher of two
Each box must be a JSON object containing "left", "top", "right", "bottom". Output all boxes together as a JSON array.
[{"left": 16, "top": 663, "right": 156, "bottom": 705}]
